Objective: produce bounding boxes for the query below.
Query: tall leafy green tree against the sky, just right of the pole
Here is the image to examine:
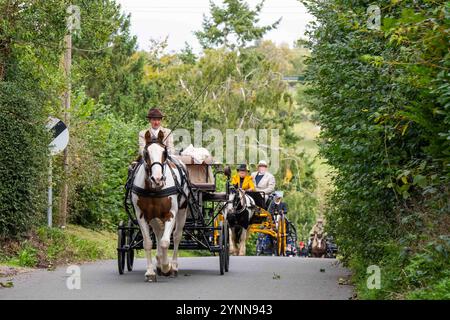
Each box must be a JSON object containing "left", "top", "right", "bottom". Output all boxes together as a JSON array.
[{"left": 73, "top": 0, "right": 150, "bottom": 118}]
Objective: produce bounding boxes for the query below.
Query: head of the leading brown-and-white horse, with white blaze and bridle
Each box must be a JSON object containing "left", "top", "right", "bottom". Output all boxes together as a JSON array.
[{"left": 143, "top": 131, "right": 168, "bottom": 189}]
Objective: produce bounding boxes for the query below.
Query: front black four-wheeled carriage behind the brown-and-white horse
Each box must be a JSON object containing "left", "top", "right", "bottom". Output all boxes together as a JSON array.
[{"left": 117, "top": 156, "right": 231, "bottom": 275}]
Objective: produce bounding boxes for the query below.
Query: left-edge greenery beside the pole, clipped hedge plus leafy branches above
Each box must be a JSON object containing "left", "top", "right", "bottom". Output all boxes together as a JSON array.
[{"left": 0, "top": 0, "right": 64, "bottom": 239}]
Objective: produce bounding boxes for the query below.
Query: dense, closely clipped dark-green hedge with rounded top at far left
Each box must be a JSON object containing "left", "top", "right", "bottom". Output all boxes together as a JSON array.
[{"left": 0, "top": 82, "right": 49, "bottom": 238}]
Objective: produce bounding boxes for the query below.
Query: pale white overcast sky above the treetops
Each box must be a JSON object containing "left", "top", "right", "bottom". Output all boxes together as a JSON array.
[{"left": 118, "top": 0, "right": 312, "bottom": 52}]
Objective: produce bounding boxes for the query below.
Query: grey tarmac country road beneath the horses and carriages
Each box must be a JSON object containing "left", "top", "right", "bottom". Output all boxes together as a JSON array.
[{"left": 0, "top": 257, "right": 353, "bottom": 300}]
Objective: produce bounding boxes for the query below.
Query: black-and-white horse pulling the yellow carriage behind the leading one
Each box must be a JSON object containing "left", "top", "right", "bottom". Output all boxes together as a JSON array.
[{"left": 227, "top": 188, "right": 256, "bottom": 256}]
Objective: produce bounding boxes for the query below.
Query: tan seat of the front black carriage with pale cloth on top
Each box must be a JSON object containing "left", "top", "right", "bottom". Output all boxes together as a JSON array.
[{"left": 172, "top": 155, "right": 216, "bottom": 191}]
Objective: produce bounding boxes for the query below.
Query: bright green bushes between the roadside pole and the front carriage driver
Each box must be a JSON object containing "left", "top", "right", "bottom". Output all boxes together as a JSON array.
[{"left": 69, "top": 91, "right": 147, "bottom": 230}]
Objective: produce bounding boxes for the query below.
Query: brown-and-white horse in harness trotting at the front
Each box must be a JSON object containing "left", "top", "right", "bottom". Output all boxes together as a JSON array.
[{"left": 131, "top": 131, "right": 189, "bottom": 282}]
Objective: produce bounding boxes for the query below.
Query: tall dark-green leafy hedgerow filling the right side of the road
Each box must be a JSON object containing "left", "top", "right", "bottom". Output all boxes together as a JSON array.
[{"left": 301, "top": 0, "right": 450, "bottom": 297}]
